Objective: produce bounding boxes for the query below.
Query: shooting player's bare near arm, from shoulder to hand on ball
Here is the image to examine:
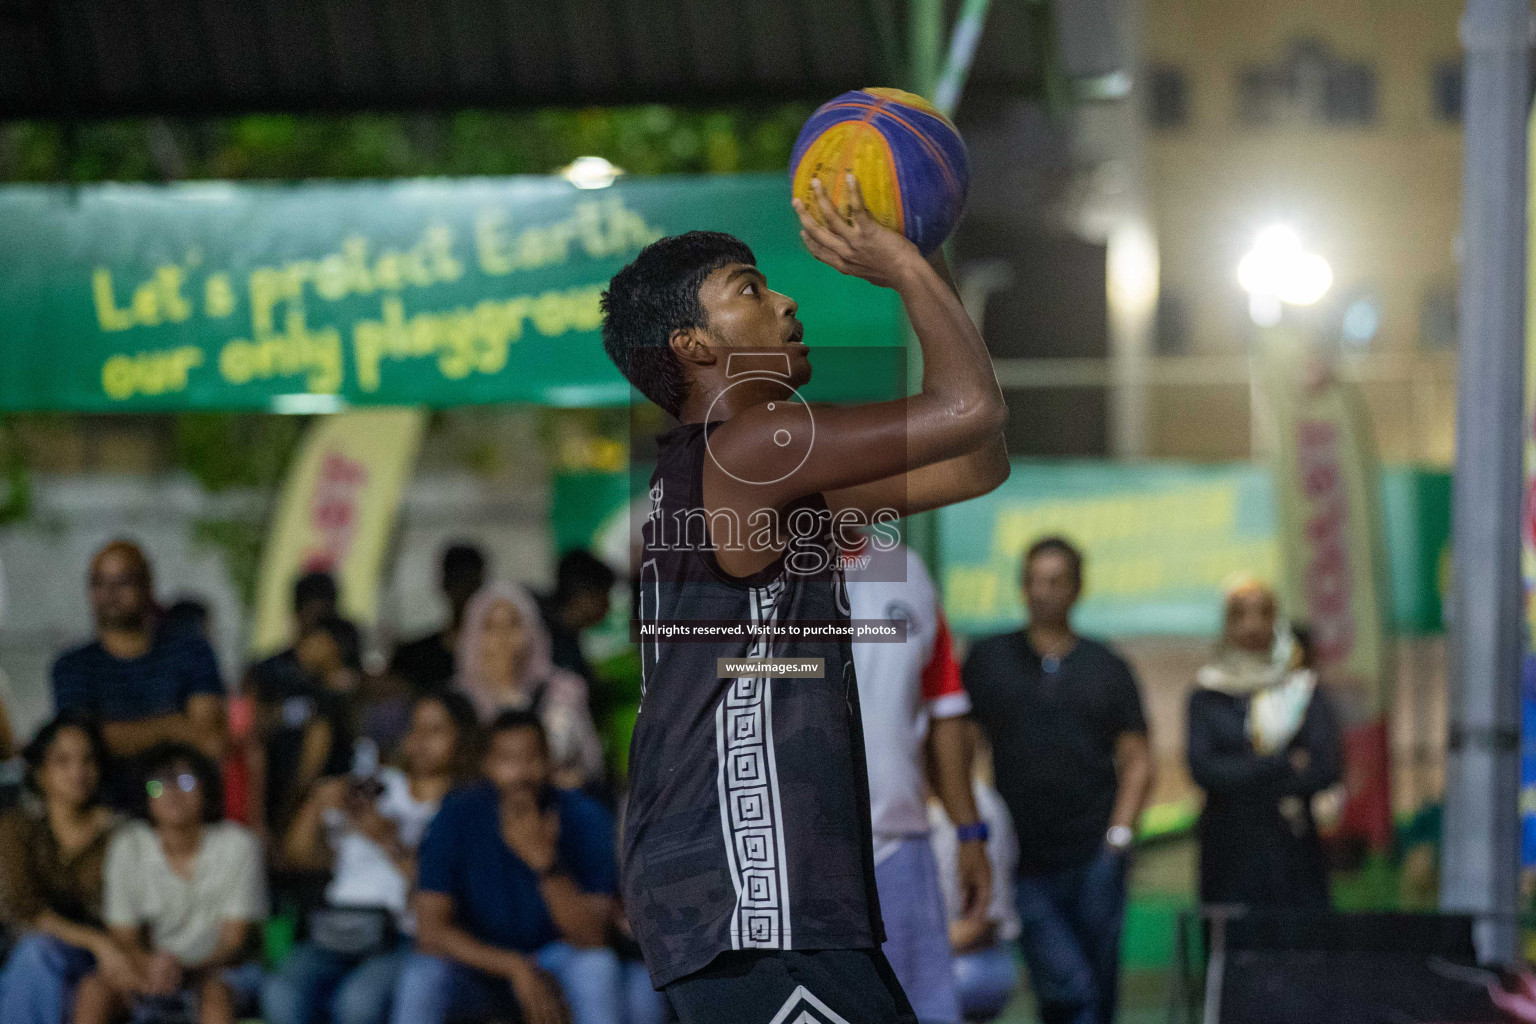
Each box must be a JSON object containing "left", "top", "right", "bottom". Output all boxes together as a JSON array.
[{"left": 705, "top": 173, "right": 1008, "bottom": 521}]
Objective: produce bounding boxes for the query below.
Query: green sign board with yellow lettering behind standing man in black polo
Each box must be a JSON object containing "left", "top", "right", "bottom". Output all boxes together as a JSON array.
[{"left": 938, "top": 461, "right": 1450, "bottom": 637}]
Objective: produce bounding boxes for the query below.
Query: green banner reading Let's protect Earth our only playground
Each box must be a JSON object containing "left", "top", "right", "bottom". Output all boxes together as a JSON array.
[{"left": 0, "top": 175, "right": 902, "bottom": 413}]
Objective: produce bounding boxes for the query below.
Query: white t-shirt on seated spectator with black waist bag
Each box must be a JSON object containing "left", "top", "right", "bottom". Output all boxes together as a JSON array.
[{"left": 324, "top": 768, "right": 438, "bottom": 933}]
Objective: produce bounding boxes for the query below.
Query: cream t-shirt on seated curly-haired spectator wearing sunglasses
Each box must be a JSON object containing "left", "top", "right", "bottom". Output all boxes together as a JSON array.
[{"left": 101, "top": 821, "right": 267, "bottom": 967}]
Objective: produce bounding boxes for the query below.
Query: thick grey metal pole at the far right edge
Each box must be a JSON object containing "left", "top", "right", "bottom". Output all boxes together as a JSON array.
[{"left": 1441, "top": 0, "right": 1531, "bottom": 963}]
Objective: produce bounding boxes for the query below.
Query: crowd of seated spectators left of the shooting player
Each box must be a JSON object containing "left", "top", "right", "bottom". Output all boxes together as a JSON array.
[{"left": 0, "top": 540, "right": 651, "bottom": 1024}]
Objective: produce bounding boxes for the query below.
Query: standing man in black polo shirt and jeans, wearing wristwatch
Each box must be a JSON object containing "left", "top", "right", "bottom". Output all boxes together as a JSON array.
[{"left": 965, "top": 537, "right": 1152, "bottom": 1024}]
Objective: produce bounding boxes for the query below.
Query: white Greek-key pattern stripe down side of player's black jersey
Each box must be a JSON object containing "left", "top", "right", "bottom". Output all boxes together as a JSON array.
[{"left": 714, "top": 582, "right": 791, "bottom": 949}]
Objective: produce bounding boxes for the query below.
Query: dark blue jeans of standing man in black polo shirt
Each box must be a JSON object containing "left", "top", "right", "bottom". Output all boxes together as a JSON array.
[{"left": 1018, "top": 847, "right": 1126, "bottom": 1024}]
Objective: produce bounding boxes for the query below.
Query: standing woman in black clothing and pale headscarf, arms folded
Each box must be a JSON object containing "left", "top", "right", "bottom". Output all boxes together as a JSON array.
[{"left": 1189, "top": 580, "right": 1342, "bottom": 910}]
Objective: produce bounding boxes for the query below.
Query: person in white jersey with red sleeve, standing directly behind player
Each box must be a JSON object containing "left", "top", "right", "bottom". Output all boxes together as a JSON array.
[{"left": 843, "top": 537, "right": 992, "bottom": 1024}]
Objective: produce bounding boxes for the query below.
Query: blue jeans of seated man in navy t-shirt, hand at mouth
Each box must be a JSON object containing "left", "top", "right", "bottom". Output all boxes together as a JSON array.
[{"left": 390, "top": 943, "right": 624, "bottom": 1024}]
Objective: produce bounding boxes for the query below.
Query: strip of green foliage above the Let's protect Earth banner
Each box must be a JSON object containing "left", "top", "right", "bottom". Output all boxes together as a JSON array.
[{"left": 0, "top": 103, "right": 811, "bottom": 183}]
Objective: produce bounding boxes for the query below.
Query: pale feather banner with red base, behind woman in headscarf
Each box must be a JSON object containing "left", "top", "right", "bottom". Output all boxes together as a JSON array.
[{"left": 1263, "top": 333, "right": 1392, "bottom": 849}]
